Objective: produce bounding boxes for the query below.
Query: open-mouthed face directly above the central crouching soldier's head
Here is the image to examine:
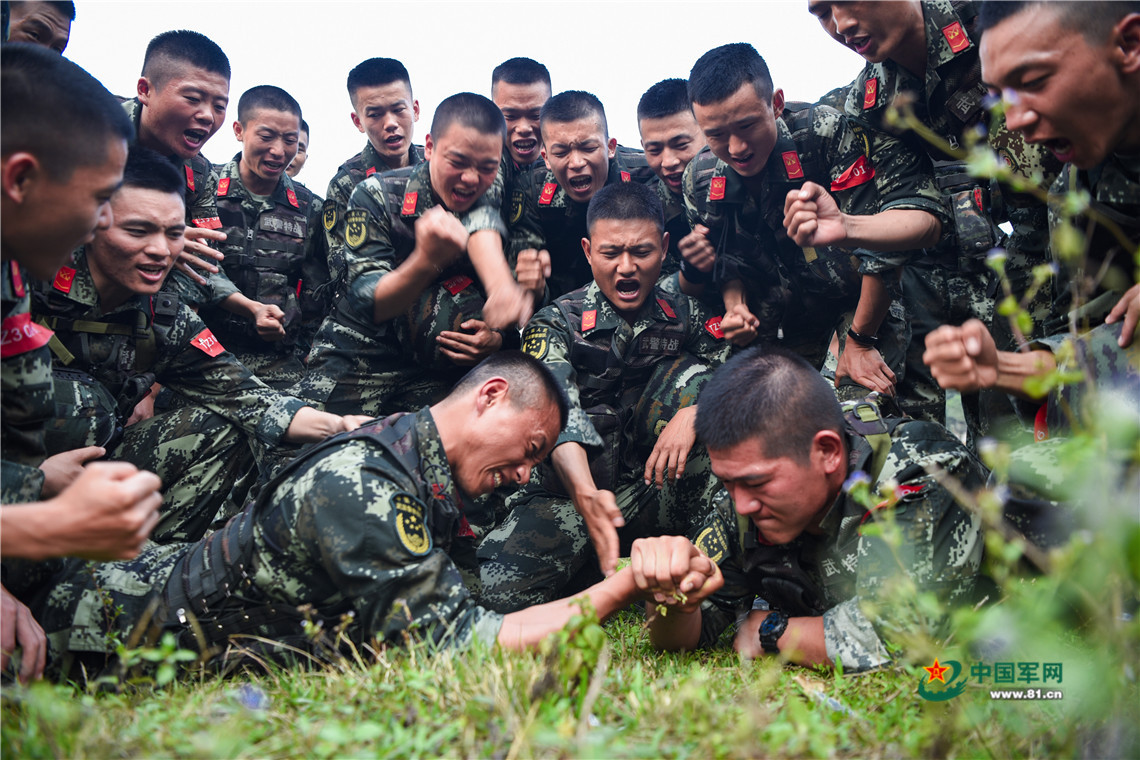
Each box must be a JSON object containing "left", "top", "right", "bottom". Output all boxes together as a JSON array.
[{"left": 543, "top": 117, "right": 618, "bottom": 203}]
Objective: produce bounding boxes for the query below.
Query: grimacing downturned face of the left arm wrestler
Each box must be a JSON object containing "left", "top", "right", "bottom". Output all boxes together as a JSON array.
[{"left": 451, "top": 400, "right": 559, "bottom": 496}]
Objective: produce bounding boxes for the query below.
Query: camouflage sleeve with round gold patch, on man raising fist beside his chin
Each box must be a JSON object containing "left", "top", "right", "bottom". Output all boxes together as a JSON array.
[{"left": 344, "top": 175, "right": 401, "bottom": 312}]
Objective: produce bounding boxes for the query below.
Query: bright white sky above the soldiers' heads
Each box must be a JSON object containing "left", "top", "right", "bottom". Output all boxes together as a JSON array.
[{"left": 65, "top": 0, "right": 863, "bottom": 196}]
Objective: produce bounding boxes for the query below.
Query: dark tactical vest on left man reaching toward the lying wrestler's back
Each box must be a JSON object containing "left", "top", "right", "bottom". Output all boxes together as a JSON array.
[{"left": 36, "top": 291, "right": 181, "bottom": 456}]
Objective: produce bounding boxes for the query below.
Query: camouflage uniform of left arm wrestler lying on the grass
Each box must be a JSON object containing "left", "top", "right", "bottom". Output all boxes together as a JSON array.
[{"left": 10, "top": 409, "right": 502, "bottom": 677}]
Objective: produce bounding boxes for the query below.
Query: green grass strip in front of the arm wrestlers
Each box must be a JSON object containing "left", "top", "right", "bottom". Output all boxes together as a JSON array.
[{"left": 0, "top": 612, "right": 1121, "bottom": 759}]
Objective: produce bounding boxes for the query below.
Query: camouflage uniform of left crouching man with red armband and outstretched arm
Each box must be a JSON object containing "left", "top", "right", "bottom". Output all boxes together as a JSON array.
[{"left": 33, "top": 253, "right": 303, "bottom": 541}]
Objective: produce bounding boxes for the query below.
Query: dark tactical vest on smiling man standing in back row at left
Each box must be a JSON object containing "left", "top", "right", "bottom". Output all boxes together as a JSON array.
[{"left": 210, "top": 178, "right": 312, "bottom": 353}]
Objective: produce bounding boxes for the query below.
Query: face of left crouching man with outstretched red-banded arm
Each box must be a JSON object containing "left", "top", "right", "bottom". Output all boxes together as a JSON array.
[{"left": 88, "top": 187, "right": 186, "bottom": 309}]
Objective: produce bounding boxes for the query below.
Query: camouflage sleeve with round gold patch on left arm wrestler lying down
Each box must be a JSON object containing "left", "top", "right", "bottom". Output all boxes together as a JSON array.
[{"left": 298, "top": 441, "right": 503, "bottom": 646}]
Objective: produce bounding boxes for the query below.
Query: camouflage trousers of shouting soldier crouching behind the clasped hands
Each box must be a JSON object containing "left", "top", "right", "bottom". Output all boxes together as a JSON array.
[{"left": 477, "top": 446, "right": 720, "bottom": 613}]
